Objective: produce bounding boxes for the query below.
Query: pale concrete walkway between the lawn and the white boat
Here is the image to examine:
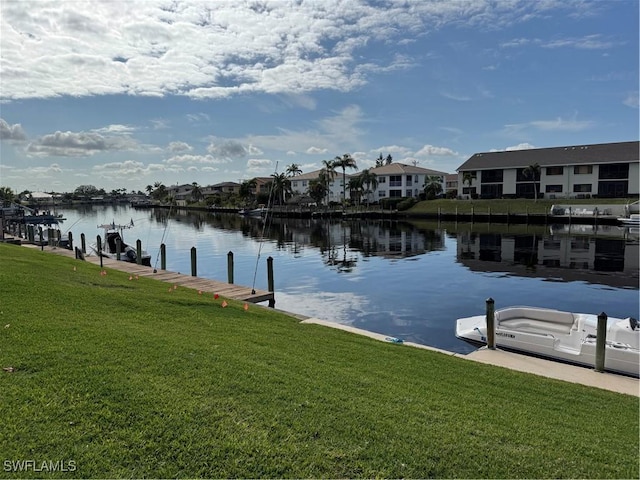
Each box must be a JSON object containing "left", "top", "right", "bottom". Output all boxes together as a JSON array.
[{"left": 302, "top": 318, "right": 640, "bottom": 397}]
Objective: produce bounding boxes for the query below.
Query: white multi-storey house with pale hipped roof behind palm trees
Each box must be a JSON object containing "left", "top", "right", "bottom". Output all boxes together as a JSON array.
[{"left": 368, "top": 163, "right": 447, "bottom": 201}]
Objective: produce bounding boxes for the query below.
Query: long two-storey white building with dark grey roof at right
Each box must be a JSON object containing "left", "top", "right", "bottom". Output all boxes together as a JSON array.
[{"left": 457, "top": 141, "right": 640, "bottom": 198}]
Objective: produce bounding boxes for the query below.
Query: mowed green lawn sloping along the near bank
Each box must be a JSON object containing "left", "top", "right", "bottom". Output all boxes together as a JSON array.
[{"left": 0, "top": 244, "right": 640, "bottom": 478}]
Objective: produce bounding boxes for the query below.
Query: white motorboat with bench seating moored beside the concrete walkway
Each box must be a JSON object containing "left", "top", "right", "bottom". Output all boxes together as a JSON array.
[{"left": 456, "top": 307, "right": 640, "bottom": 377}]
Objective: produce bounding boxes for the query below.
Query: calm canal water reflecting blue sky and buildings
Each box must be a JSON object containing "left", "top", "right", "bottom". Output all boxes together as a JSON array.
[{"left": 61, "top": 206, "right": 640, "bottom": 353}]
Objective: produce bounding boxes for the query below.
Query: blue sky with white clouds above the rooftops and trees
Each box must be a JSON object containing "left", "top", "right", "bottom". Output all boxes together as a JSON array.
[{"left": 0, "top": 0, "right": 639, "bottom": 192}]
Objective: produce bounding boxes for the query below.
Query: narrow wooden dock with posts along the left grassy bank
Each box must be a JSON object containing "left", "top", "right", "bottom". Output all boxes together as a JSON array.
[{"left": 22, "top": 243, "right": 275, "bottom": 307}]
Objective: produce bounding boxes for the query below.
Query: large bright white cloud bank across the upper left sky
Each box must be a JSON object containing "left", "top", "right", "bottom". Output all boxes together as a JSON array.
[{"left": 0, "top": 0, "right": 576, "bottom": 100}]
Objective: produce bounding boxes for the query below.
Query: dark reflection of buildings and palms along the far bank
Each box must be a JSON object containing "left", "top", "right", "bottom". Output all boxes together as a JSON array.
[{"left": 136, "top": 205, "right": 640, "bottom": 288}]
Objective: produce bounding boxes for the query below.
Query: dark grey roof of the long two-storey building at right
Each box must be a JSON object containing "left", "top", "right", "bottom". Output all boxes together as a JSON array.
[{"left": 458, "top": 142, "right": 640, "bottom": 171}]
